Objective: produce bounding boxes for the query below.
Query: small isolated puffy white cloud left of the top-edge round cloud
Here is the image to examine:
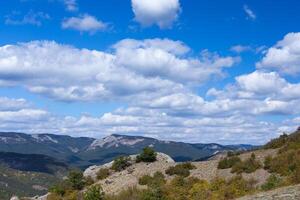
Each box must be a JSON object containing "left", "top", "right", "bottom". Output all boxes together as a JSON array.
[{"left": 62, "top": 14, "right": 108, "bottom": 33}]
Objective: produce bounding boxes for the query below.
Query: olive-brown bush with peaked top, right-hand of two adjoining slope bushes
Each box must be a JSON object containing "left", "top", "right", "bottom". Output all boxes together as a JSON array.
[{"left": 231, "top": 153, "right": 262, "bottom": 174}]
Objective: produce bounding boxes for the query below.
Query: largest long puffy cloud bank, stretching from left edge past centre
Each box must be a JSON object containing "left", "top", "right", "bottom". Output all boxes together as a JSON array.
[{"left": 0, "top": 39, "right": 235, "bottom": 101}]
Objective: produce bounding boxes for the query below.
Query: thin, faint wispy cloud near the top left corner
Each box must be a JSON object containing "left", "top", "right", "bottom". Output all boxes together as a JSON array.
[{"left": 5, "top": 11, "right": 50, "bottom": 26}]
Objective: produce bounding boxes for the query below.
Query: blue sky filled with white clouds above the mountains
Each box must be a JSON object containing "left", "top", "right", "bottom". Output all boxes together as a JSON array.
[{"left": 0, "top": 0, "right": 300, "bottom": 144}]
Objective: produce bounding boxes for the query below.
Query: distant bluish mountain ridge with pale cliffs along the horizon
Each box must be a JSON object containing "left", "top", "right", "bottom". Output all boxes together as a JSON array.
[{"left": 0, "top": 132, "right": 253, "bottom": 169}]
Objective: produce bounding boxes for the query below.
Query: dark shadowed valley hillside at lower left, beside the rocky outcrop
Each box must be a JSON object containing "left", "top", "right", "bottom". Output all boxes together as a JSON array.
[{"left": 0, "top": 152, "right": 69, "bottom": 200}]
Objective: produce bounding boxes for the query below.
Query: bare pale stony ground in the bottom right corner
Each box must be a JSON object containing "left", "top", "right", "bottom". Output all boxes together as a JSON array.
[{"left": 238, "top": 185, "right": 300, "bottom": 200}]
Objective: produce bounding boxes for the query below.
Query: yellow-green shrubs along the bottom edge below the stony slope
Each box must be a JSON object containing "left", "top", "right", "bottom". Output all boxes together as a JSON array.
[{"left": 106, "top": 176, "right": 255, "bottom": 200}]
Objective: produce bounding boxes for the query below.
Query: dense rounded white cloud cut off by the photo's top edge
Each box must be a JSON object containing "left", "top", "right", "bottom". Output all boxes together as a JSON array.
[{"left": 131, "top": 0, "right": 181, "bottom": 29}]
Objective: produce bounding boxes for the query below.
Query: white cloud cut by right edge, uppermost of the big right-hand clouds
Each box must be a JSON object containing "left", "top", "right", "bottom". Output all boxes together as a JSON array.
[{"left": 256, "top": 33, "right": 300, "bottom": 76}]
